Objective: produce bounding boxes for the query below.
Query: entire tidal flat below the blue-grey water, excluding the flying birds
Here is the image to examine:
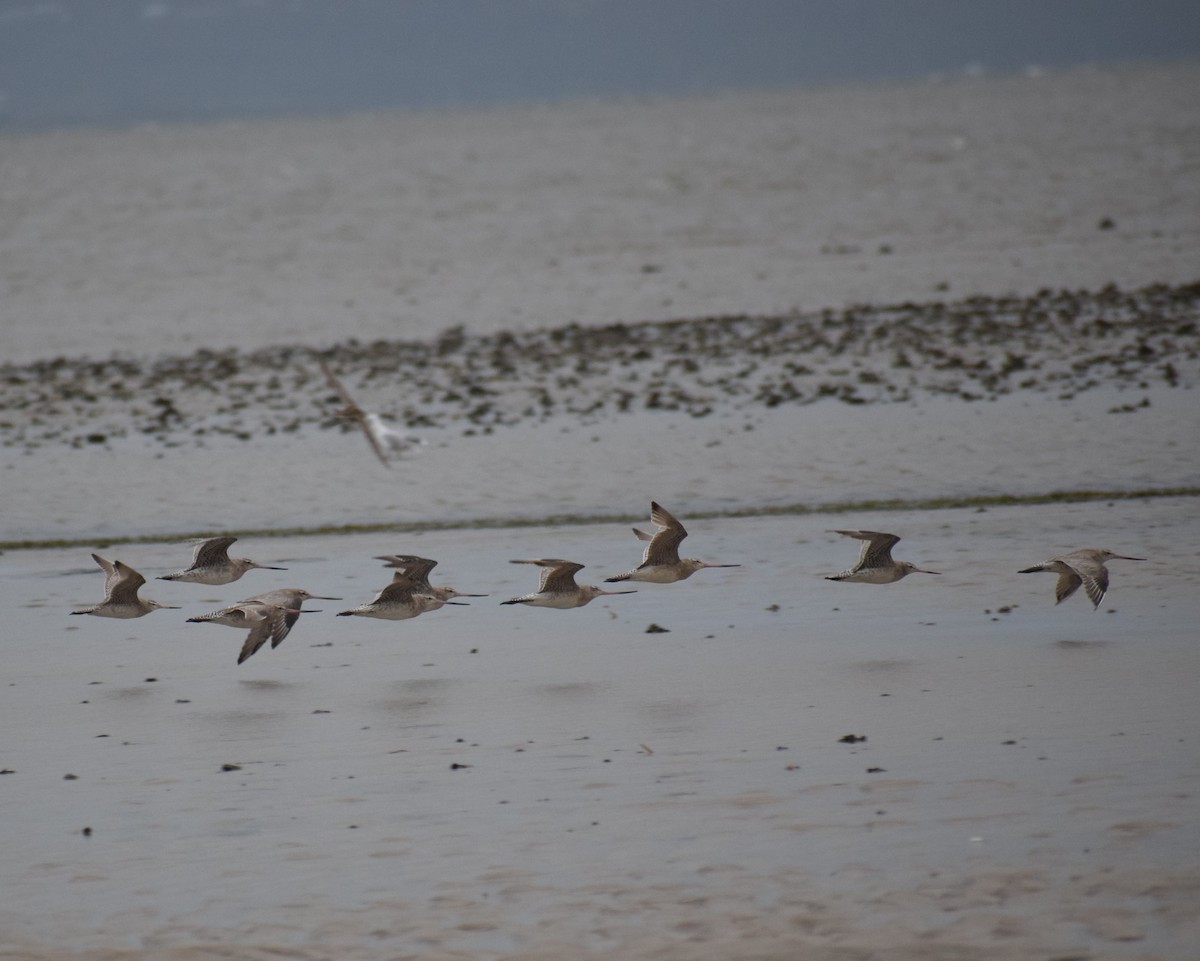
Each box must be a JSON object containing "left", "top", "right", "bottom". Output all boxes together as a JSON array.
[{"left": 0, "top": 65, "right": 1200, "bottom": 961}]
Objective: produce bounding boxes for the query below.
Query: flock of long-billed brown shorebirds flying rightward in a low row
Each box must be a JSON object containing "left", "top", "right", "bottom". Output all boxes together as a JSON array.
[{"left": 71, "top": 503, "right": 1145, "bottom": 663}]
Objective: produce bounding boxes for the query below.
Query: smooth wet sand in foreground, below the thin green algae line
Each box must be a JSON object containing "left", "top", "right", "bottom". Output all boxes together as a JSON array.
[{"left": 7, "top": 498, "right": 1200, "bottom": 959}]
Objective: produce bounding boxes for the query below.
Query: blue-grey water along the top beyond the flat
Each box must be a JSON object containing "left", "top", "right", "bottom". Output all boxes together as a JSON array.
[{"left": 0, "top": 0, "right": 1200, "bottom": 130}]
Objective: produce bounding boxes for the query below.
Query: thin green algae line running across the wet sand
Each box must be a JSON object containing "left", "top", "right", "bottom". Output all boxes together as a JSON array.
[{"left": 0, "top": 486, "right": 1200, "bottom": 551}]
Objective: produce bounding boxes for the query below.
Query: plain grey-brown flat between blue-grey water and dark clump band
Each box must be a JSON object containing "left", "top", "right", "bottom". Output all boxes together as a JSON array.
[{"left": 0, "top": 64, "right": 1200, "bottom": 362}]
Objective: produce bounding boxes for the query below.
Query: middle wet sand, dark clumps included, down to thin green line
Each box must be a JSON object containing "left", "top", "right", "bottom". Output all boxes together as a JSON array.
[{"left": 0, "top": 286, "right": 1200, "bottom": 546}]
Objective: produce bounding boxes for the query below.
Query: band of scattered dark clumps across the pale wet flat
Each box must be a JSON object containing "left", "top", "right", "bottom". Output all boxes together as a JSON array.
[{"left": 0, "top": 282, "right": 1200, "bottom": 449}]
